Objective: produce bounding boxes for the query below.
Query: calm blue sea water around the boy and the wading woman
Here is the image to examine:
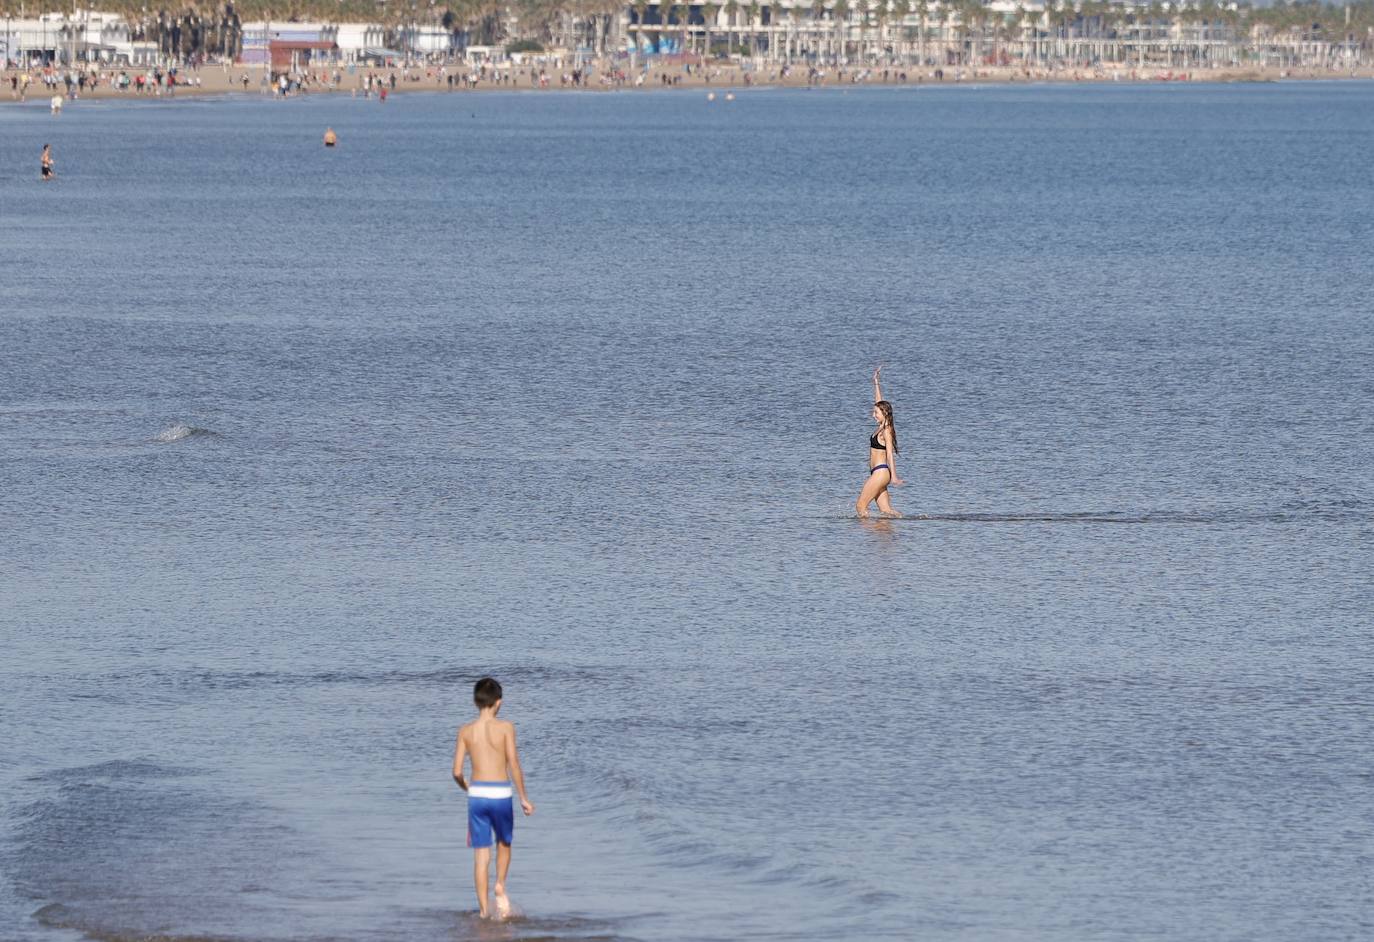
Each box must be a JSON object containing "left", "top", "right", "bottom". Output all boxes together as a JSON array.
[{"left": 0, "top": 82, "right": 1374, "bottom": 942}]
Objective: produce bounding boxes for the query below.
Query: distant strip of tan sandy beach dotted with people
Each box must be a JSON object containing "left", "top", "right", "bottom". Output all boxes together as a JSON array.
[{"left": 0, "top": 63, "right": 1374, "bottom": 102}]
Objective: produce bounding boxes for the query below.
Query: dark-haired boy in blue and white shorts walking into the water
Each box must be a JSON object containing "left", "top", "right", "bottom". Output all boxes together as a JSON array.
[{"left": 453, "top": 677, "right": 534, "bottom": 919}]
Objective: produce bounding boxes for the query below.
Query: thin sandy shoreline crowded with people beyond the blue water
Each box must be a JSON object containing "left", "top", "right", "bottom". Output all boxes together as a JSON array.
[{"left": 0, "top": 66, "right": 1374, "bottom": 107}]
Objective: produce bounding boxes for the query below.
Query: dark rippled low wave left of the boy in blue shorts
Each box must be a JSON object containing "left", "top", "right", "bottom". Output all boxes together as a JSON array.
[{"left": 12, "top": 758, "right": 302, "bottom": 942}]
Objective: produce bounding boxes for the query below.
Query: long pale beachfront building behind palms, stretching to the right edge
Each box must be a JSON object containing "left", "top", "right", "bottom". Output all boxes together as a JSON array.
[{"left": 604, "top": 0, "right": 1374, "bottom": 69}]
